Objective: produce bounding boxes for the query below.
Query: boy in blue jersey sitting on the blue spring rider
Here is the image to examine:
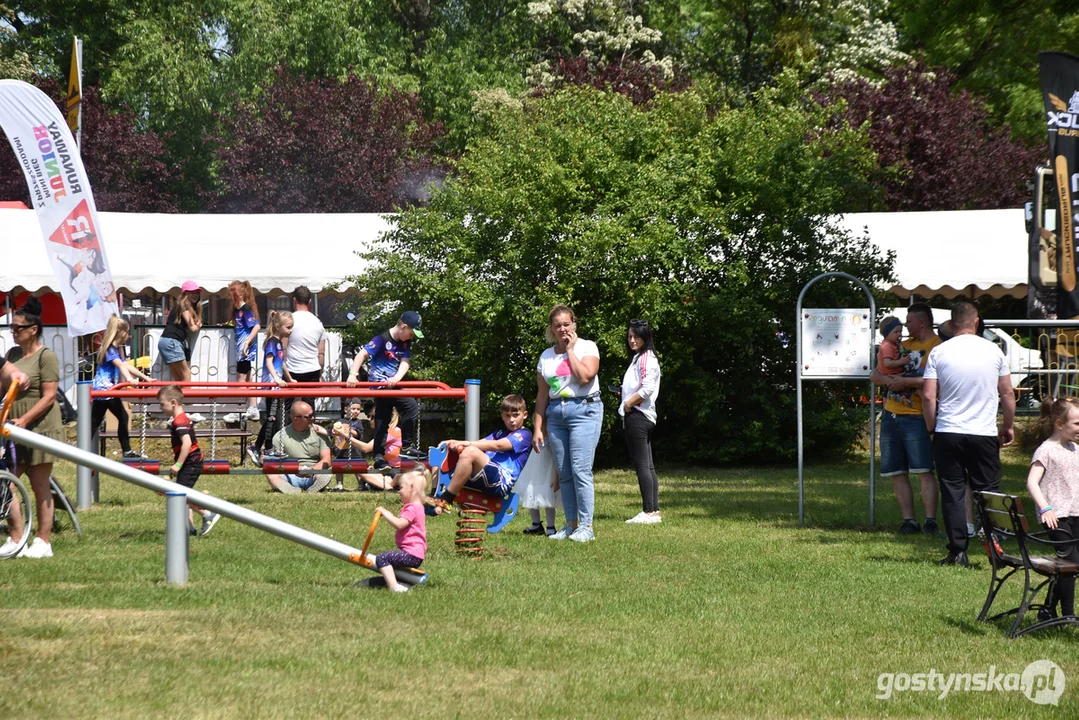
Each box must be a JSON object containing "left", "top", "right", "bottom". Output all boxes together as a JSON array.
[{"left": 435, "top": 395, "right": 532, "bottom": 503}]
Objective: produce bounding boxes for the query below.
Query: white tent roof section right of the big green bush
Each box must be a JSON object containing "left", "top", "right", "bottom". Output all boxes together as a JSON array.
[{"left": 839, "top": 209, "right": 1028, "bottom": 298}]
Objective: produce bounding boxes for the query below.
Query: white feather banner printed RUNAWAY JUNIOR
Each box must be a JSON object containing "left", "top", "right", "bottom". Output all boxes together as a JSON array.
[{"left": 0, "top": 80, "right": 117, "bottom": 337}]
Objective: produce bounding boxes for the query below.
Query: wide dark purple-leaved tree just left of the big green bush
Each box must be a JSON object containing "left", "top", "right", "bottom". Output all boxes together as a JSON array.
[{"left": 206, "top": 68, "right": 443, "bottom": 213}]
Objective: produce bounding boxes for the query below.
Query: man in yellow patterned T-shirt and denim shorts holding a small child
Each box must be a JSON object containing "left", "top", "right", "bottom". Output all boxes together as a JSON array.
[{"left": 872, "top": 302, "right": 941, "bottom": 535}]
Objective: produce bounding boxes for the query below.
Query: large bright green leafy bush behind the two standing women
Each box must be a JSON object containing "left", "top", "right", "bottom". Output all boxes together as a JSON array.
[{"left": 345, "top": 82, "right": 890, "bottom": 462}]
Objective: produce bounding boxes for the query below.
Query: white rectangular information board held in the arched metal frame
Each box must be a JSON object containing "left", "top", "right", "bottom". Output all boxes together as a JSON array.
[{"left": 802, "top": 308, "right": 874, "bottom": 378}]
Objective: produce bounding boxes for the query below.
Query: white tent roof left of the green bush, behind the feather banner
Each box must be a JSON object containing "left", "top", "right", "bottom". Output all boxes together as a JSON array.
[{"left": 0, "top": 209, "right": 391, "bottom": 294}]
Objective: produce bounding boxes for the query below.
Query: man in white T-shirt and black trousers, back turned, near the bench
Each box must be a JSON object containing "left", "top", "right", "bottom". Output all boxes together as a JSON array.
[{"left": 921, "top": 302, "right": 1015, "bottom": 567}]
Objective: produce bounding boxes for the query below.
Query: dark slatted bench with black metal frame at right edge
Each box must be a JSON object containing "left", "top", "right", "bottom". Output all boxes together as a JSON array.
[{"left": 973, "top": 491, "right": 1079, "bottom": 638}]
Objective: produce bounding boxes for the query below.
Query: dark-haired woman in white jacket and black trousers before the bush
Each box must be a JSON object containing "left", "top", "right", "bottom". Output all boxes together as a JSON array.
[{"left": 618, "top": 320, "right": 663, "bottom": 525}]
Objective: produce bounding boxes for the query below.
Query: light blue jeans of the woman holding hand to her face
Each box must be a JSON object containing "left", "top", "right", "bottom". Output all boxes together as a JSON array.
[{"left": 547, "top": 398, "right": 603, "bottom": 528}]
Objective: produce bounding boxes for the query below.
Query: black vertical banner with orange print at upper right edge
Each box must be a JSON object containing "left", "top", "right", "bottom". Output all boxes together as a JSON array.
[{"left": 1038, "top": 53, "right": 1079, "bottom": 320}]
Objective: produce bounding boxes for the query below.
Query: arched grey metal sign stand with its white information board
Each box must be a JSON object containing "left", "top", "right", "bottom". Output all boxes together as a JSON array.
[{"left": 794, "top": 272, "right": 876, "bottom": 526}]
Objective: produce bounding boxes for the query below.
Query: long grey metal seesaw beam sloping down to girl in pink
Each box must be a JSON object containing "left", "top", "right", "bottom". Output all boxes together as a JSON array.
[{"left": 2, "top": 423, "right": 427, "bottom": 585}]
